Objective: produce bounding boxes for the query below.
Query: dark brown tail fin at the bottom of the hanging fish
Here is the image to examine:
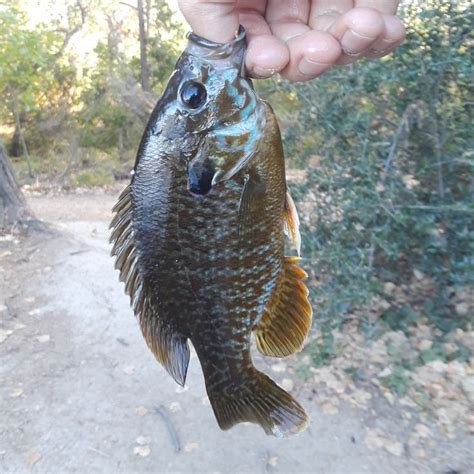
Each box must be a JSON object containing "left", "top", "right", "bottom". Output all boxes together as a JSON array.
[{"left": 209, "top": 369, "right": 308, "bottom": 438}]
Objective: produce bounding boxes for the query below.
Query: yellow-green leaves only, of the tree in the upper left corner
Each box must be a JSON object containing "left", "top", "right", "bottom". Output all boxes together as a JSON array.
[{"left": 0, "top": 2, "right": 76, "bottom": 142}]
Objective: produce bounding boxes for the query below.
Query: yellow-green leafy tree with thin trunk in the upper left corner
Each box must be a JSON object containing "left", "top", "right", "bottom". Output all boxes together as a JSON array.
[{"left": 0, "top": 0, "right": 86, "bottom": 173}]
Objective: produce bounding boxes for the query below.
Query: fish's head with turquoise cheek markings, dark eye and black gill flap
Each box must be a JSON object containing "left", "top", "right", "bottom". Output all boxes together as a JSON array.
[{"left": 140, "top": 27, "right": 265, "bottom": 195}]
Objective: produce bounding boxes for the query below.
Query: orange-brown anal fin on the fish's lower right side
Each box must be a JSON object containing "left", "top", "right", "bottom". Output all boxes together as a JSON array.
[{"left": 253, "top": 257, "right": 312, "bottom": 357}]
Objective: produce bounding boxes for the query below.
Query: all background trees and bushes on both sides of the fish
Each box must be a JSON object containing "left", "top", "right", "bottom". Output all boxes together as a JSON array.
[{"left": 0, "top": 0, "right": 474, "bottom": 376}]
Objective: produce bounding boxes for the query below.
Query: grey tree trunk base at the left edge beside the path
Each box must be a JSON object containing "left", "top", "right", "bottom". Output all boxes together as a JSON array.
[{"left": 0, "top": 142, "right": 27, "bottom": 230}]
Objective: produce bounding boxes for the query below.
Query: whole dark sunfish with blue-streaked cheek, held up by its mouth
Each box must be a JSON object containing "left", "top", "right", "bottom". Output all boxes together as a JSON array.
[{"left": 110, "top": 27, "right": 312, "bottom": 437}]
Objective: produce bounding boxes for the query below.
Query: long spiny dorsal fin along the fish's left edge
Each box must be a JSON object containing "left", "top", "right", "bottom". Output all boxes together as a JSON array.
[{"left": 110, "top": 185, "right": 189, "bottom": 386}]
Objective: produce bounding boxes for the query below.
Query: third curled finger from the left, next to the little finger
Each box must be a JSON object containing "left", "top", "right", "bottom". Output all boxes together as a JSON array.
[{"left": 329, "top": 8, "right": 385, "bottom": 64}]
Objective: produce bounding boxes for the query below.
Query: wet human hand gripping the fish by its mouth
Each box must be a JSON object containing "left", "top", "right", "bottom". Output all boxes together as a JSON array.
[{"left": 179, "top": 0, "right": 405, "bottom": 81}]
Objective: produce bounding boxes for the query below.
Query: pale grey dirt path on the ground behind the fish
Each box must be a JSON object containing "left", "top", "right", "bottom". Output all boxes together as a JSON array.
[{"left": 0, "top": 194, "right": 469, "bottom": 473}]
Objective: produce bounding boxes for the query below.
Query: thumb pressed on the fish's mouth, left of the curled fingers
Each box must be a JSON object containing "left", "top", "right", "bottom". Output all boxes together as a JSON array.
[{"left": 178, "top": 0, "right": 239, "bottom": 43}]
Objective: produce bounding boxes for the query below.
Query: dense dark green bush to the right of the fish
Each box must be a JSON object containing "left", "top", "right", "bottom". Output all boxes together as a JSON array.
[{"left": 263, "top": 0, "right": 474, "bottom": 336}]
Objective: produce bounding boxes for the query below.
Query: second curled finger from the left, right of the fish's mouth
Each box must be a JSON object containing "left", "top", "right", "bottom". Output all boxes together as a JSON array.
[{"left": 281, "top": 29, "right": 341, "bottom": 81}]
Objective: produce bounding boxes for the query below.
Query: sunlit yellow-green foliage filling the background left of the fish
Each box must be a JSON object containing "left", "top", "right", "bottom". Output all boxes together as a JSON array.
[{"left": 0, "top": 0, "right": 184, "bottom": 179}]
